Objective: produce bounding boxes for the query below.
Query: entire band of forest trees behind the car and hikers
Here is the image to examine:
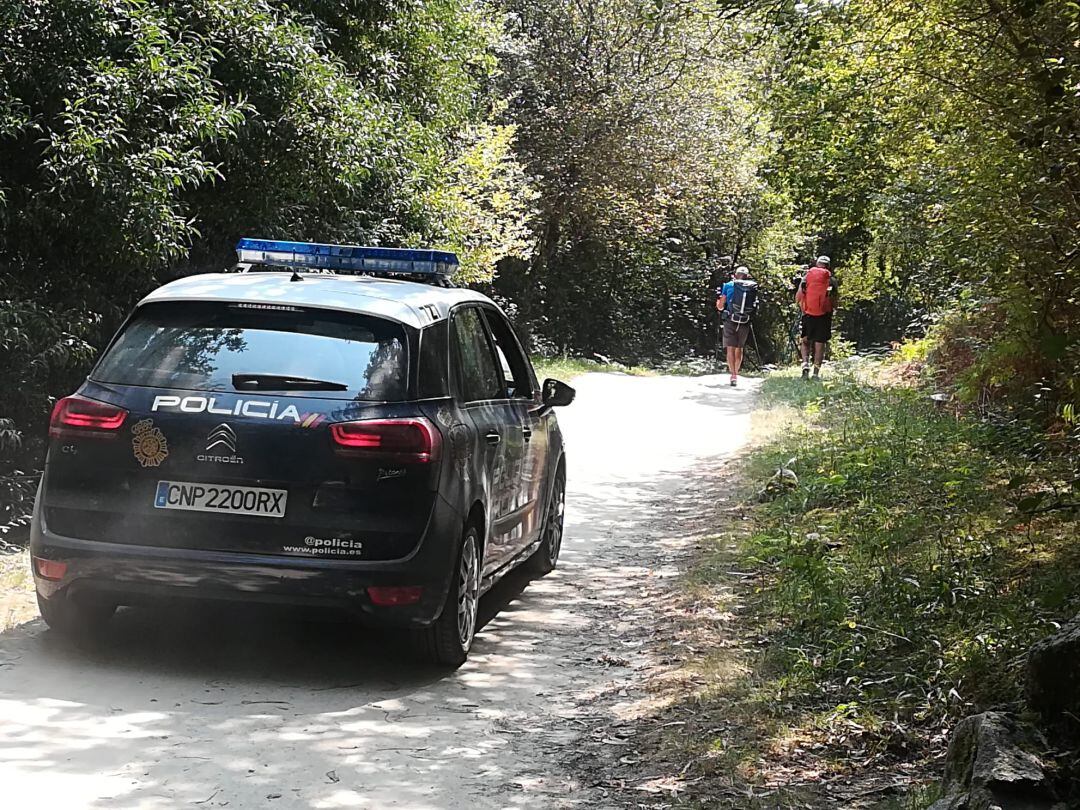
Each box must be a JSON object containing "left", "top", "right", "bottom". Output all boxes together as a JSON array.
[{"left": 0, "top": 0, "right": 1080, "bottom": 534}]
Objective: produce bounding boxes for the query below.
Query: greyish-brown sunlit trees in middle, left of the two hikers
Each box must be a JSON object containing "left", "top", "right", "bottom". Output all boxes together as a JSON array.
[{"left": 498, "top": 0, "right": 791, "bottom": 362}]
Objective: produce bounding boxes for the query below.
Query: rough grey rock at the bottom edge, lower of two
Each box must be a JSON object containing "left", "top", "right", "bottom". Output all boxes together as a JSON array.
[{"left": 930, "top": 712, "right": 1055, "bottom": 810}]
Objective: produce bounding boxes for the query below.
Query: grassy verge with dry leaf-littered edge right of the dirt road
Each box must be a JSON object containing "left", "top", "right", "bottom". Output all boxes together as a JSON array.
[{"left": 587, "top": 362, "right": 1080, "bottom": 810}]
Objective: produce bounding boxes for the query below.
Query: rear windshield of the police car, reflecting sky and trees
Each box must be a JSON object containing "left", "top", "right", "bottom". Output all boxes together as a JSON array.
[{"left": 92, "top": 302, "right": 408, "bottom": 402}]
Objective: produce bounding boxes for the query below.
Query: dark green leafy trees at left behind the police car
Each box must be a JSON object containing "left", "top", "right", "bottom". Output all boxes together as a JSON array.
[{"left": 0, "top": 0, "right": 532, "bottom": 533}]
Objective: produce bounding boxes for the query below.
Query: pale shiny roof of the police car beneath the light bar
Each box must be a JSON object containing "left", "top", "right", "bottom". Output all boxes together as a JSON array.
[{"left": 139, "top": 271, "right": 494, "bottom": 329}]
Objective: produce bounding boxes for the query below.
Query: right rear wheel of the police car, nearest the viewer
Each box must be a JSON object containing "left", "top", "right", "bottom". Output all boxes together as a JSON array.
[{"left": 414, "top": 526, "right": 481, "bottom": 667}]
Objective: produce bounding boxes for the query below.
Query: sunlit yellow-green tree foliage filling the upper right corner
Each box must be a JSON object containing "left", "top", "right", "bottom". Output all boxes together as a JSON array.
[{"left": 764, "top": 0, "right": 1080, "bottom": 411}]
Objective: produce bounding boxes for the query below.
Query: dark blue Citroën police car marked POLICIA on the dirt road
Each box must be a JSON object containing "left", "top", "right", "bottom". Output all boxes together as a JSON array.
[{"left": 31, "top": 239, "right": 573, "bottom": 665}]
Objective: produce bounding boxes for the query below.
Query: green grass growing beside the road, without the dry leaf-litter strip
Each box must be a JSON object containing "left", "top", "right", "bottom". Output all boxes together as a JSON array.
[{"left": 669, "top": 366, "right": 1080, "bottom": 808}]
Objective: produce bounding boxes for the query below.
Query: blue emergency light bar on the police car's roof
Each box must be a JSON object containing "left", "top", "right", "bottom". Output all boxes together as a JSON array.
[{"left": 237, "top": 239, "right": 459, "bottom": 276}]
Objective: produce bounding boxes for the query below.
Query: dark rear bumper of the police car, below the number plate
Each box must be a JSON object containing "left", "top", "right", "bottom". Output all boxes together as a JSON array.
[{"left": 30, "top": 498, "right": 463, "bottom": 627}]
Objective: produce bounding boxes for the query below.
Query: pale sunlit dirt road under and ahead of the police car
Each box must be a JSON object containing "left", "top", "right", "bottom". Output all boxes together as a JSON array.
[{"left": 0, "top": 375, "right": 752, "bottom": 810}]
